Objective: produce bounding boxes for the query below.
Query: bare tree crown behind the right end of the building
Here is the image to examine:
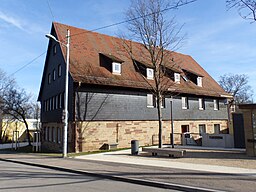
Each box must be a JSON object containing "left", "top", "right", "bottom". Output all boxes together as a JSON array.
[{"left": 219, "top": 74, "right": 253, "bottom": 104}]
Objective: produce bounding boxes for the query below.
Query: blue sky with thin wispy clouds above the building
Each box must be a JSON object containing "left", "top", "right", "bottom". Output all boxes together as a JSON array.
[{"left": 0, "top": 0, "right": 256, "bottom": 100}]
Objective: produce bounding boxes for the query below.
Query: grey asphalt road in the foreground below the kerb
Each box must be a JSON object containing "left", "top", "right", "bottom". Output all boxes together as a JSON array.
[{"left": 0, "top": 161, "right": 178, "bottom": 192}]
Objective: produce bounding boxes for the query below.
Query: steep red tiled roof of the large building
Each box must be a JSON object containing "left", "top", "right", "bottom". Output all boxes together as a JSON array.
[{"left": 53, "top": 22, "right": 228, "bottom": 97}]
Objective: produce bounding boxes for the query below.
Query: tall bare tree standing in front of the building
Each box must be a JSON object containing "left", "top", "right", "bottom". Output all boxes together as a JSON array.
[{"left": 124, "top": 0, "right": 194, "bottom": 148}]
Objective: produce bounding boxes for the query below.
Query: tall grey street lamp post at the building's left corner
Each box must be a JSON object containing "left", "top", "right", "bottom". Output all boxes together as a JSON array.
[{"left": 46, "top": 30, "right": 70, "bottom": 158}]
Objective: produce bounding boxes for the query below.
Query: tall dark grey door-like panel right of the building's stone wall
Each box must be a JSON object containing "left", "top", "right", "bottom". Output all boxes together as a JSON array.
[{"left": 232, "top": 113, "right": 245, "bottom": 148}]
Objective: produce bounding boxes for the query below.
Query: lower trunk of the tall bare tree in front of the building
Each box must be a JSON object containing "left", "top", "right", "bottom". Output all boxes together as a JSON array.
[{"left": 157, "top": 93, "right": 163, "bottom": 148}]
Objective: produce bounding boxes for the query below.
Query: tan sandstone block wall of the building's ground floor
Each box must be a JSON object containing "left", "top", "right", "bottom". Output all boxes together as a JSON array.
[{"left": 75, "top": 120, "right": 227, "bottom": 152}]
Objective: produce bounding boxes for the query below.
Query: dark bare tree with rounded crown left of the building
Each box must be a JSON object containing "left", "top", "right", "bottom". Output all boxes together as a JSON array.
[{"left": 1, "top": 87, "right": 32, "bottom": 145}]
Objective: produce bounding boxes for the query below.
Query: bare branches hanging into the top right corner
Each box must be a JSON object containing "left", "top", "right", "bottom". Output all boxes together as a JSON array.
[{"left": 226, "top": 0, "right": 256, "bottom": 22}]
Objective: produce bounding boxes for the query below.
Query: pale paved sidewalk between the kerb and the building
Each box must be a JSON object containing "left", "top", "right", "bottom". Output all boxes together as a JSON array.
[{"left": 0, "top": 150, "right": 256, "bottom": 191}]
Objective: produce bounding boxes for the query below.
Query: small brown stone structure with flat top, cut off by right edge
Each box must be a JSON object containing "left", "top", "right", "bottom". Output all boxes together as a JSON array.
[{"left": 238, "top": 104, "right": 256, "bottom": 156}]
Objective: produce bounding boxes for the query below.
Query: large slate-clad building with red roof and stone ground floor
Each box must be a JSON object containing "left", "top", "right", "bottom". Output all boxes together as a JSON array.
[{"left": 38, "top": 23, "right": 232, "bottom": 152}]
